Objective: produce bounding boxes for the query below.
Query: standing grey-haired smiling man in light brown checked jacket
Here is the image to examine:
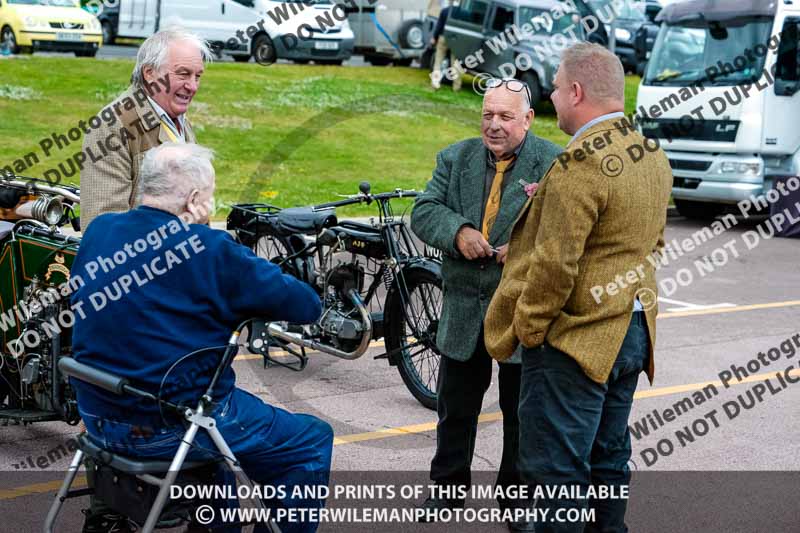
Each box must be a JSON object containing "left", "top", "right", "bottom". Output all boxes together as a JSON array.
[{"left": 81, "top": 29, "right": 206, "bottom": 230}]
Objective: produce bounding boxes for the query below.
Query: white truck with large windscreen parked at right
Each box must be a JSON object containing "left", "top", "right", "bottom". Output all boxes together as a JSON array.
[{"left": 636, "top": 0, "right": 800, "bottom": 219}]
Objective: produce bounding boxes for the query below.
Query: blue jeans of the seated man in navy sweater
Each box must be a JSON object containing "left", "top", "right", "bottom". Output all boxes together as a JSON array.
[{"left": 81, "top": 389, "right": 333, "bottom": 533}]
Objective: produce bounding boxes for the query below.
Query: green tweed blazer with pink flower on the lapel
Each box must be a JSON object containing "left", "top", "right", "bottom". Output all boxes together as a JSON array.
[{"left": 411, "top": 133, "right": 561, "bottom": 362}]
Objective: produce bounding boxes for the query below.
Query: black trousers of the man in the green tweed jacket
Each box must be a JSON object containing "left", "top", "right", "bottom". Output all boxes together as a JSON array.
[{"left": 431, "top": 332, "right": 522, "bottom": 506}]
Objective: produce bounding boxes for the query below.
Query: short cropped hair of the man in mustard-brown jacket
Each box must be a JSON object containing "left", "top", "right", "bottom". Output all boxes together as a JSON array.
[{"left": 561, "top": 42, "right": 625, "bottom": 104}]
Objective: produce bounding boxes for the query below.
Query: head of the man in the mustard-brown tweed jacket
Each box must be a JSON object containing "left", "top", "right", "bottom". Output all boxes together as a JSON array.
[{"left": 550, "top": 42, "right": 625, "bottom": 135}]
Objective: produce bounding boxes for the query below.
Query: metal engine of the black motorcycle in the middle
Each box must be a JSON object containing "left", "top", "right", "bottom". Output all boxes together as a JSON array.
[{"left": 320, "top": 263, "right": 364, "bottom": 351}]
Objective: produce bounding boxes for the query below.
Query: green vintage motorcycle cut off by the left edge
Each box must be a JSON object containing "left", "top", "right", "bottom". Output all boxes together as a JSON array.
[{"left": 0, "top": 171, "right": 80, "bottom": 425}]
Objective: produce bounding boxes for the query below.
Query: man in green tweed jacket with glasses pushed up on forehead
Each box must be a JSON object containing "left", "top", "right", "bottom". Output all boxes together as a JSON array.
[{"left": 411, "top": 80, "right": 561, "bottom": 531}]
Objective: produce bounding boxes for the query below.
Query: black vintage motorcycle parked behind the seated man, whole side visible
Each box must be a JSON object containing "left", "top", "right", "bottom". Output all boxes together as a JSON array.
[{"left": 228, "top": 182, "right": 443, "bottom": 409}]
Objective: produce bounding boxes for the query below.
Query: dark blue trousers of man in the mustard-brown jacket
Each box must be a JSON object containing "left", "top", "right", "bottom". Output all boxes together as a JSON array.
[{"left": 519, "top": 312, "right": 650, "bottom": 533}]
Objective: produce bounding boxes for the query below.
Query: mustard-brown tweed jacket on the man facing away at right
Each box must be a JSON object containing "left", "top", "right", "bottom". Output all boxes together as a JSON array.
[{"left": 485, "top": 119, "right": 672, "bottom": 383}]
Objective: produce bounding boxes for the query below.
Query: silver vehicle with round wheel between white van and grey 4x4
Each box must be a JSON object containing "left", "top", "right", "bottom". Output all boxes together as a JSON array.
[{"left": 345, "top": 0, "right": 429, "bottom": 66}]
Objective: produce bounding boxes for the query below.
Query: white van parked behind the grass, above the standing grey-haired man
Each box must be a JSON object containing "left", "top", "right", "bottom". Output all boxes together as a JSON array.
[{"left": 116, "top": 0, "right": 355, "bottom": 64}]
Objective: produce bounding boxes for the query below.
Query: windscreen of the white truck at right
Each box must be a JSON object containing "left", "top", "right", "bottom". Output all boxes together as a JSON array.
[{"left": 644, "top": 17, "right": 772, "bottom": 86}]
